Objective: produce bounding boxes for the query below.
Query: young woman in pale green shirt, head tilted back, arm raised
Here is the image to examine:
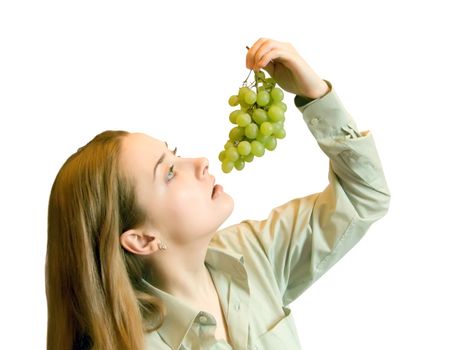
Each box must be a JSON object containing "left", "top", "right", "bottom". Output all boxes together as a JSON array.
[{"left": 46, "top": 39, "right": 390, "bottom": 350}]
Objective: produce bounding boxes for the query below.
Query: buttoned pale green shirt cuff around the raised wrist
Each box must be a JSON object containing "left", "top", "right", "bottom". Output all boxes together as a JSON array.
[{"left": 294, "top": 79, "right": 362, "bottom": 140}]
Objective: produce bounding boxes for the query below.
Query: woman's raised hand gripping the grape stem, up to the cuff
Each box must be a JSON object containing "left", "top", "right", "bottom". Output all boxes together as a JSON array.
[{"left": 246, "top": 38, "right": 329, "bottom": 98}]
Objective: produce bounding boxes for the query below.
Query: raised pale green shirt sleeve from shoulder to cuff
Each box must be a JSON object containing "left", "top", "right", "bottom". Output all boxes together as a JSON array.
[{"left": 241, "top": 81, "right": 390, "bottom": 305}]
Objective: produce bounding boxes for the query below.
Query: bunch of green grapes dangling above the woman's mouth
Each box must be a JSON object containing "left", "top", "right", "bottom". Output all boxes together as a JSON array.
[{"left": 218, "top": 71, "right": 287, "bottom": 173}]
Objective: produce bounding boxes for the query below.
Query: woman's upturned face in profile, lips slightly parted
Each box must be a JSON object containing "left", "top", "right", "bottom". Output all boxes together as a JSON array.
[{"left": 120, "top": 133, "right": 234, "bottom": 244}]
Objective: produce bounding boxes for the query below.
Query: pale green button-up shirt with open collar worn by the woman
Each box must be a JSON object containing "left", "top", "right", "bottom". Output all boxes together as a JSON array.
[{"left": 144, "top": 81, "right": 390, "bottom": 350}]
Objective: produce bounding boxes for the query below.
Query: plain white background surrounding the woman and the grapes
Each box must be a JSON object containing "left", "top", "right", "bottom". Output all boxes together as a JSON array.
[{"left": 0, "top": 0, "right": 459, "bottom": 350}]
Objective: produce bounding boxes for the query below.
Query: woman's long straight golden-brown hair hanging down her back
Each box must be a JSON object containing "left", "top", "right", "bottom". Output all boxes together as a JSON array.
[{"left": 46, "top": 131, "right": 164, "bottom": 350}]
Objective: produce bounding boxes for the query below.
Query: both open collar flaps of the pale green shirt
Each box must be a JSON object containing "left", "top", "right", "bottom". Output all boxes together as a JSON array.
[{"left": 142, "top": 247, "right": 246, "bottom": 349}]
